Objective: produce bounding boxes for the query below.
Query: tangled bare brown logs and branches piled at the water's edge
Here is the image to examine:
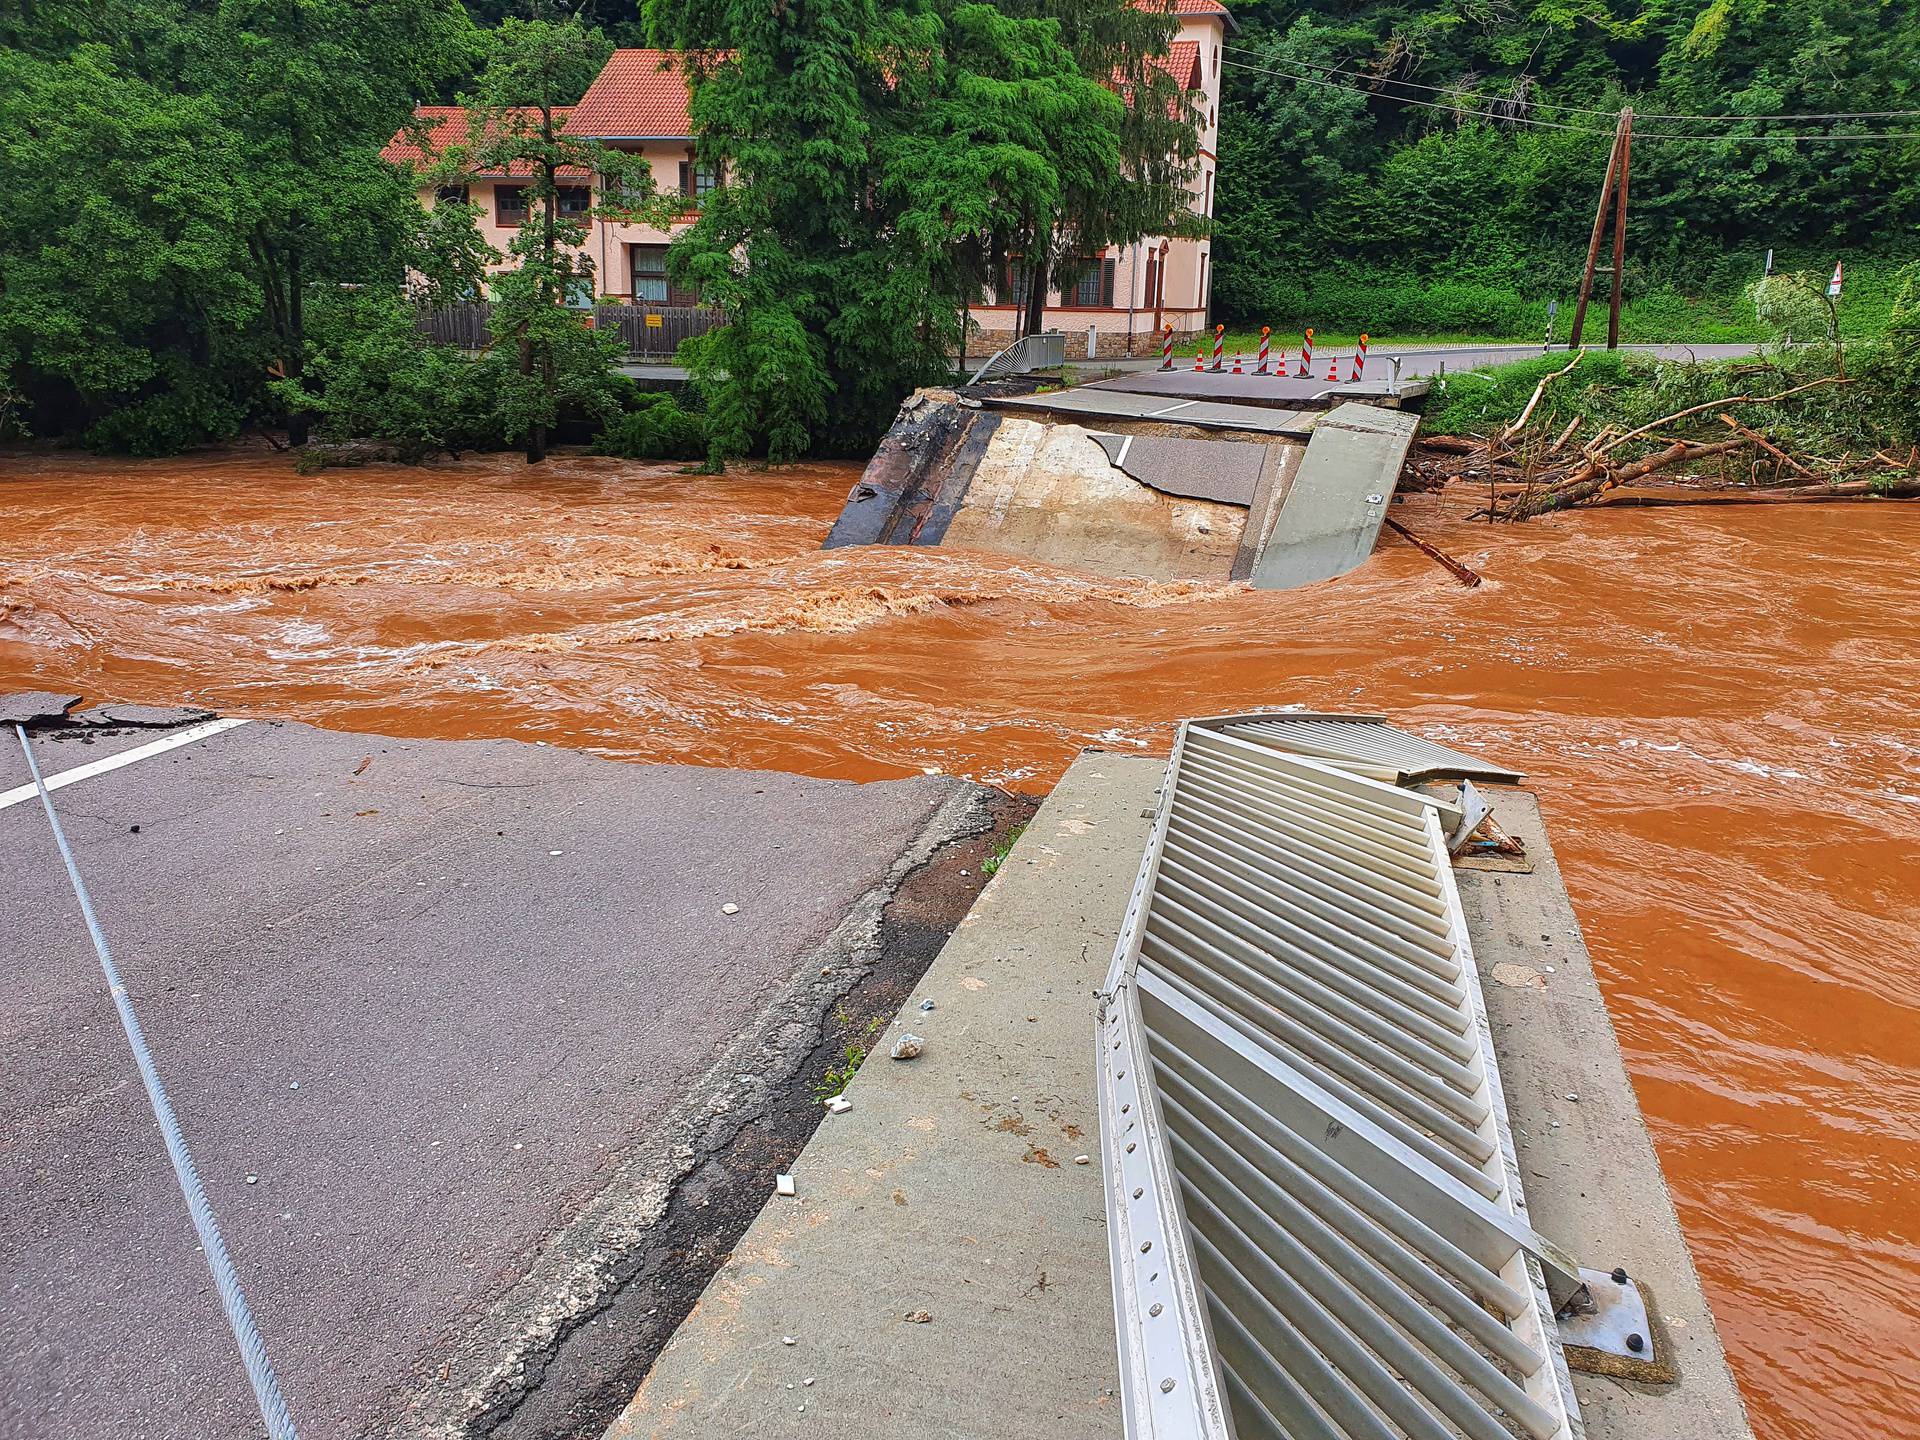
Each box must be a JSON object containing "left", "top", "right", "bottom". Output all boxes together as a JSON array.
[{"left": 1400, "top": 351, "right": 1920, "bottom": 520}]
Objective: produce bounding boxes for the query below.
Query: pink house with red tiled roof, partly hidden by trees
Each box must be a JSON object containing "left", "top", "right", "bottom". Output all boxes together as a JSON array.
[{"left": 382, "top": 10, "right": 1231, "bottom": 355}]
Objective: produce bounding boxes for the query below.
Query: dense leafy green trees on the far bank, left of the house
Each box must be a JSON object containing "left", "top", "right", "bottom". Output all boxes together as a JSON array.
[{"left": 0, "top": 0, "right": 470, "bottom": 449}]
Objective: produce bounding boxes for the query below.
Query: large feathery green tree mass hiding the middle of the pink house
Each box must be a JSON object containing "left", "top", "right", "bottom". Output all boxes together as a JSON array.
[{"left": 647, "top": 0, "right": 1192, "bottom": 463}]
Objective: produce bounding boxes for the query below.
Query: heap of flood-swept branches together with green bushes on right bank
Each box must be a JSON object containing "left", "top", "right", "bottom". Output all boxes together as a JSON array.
[{"left": 1404, "top": 330, "right": 1920, "bottom": 520}]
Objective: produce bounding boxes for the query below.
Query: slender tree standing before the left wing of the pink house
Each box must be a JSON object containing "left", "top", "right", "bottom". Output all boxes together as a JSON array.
[{"left": 453, "top": 15, "right": 659, "bottom": 465}]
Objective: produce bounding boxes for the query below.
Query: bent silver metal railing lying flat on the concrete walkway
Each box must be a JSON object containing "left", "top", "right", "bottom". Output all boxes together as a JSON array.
[{"left": 1098, "top": 716, "right": 1580, "bottom": 1440}]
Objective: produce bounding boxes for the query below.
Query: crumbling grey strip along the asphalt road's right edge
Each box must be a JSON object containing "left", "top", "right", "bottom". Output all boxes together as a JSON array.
[{"left": 382, "top": 781, "right": 993, "bottom": 1440}]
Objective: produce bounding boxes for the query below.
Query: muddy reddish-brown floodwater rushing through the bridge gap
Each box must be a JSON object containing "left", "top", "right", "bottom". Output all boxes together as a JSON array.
[{"left": 0, "top": 455, "right": 1920, "bottom": 1440}]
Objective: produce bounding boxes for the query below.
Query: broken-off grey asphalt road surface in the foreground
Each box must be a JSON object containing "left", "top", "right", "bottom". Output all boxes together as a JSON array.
[{"left": 0, "top": 722, "right": 979, "bottom": 1440}]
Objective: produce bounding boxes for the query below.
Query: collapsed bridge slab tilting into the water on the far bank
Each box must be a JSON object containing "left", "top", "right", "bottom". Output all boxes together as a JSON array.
[{"left": 826, "top": 388, "right": 1417, "bottom": 589}]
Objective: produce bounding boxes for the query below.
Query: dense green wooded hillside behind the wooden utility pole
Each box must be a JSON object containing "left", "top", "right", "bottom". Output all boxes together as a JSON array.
[{"left": 1215, "top": 0, "right": 1920, "bottom": 340}]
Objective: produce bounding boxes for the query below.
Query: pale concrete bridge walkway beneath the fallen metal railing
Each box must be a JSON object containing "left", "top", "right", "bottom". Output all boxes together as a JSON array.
[{"left": 609, "top": 751, "right": 1751, "bottom": 1440}]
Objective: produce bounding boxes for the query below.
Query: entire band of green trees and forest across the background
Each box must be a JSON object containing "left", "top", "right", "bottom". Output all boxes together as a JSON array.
[{"left": 0, "top": 0, "right": 1920, "bottom": 461}]
